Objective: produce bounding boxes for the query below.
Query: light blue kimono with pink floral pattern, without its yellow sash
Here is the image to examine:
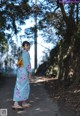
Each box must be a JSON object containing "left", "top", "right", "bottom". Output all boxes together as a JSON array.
[{"left": 13, "top": 50, "right": 31, "bottom": 102}]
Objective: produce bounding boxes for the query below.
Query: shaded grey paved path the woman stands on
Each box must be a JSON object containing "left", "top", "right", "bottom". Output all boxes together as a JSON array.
[{"left": 0, "top": 74, "right": 76, "bottom": 116}]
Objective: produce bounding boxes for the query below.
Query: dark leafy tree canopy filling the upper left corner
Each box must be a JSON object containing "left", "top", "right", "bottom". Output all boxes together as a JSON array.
[{"left": 0, "top": 0, "right": 31, "bottom": 42}]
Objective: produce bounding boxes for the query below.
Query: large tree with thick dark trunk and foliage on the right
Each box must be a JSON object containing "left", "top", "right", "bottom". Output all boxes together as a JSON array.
[{"left": 35, "top": 0, "right": 80, "bottom": 79}]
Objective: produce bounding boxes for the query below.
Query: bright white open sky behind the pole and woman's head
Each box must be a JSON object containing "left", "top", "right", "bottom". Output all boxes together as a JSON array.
[{"left": 12, "top": 20, "right": 53, "bottom": 68}]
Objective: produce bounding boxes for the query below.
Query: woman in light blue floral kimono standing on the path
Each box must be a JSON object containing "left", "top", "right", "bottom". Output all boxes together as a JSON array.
[{"left": 12, "top": 41, "right": 31, "bottom": 109}]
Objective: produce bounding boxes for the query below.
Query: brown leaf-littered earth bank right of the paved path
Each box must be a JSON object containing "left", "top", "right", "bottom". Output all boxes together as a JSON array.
[{"left": 45, "top": 79, "right": 80, "bottom": 116}]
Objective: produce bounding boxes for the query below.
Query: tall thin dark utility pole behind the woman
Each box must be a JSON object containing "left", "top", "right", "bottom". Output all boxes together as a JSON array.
[{"left": 34, "top": 0, "right": 37, "bottom": 70}]
